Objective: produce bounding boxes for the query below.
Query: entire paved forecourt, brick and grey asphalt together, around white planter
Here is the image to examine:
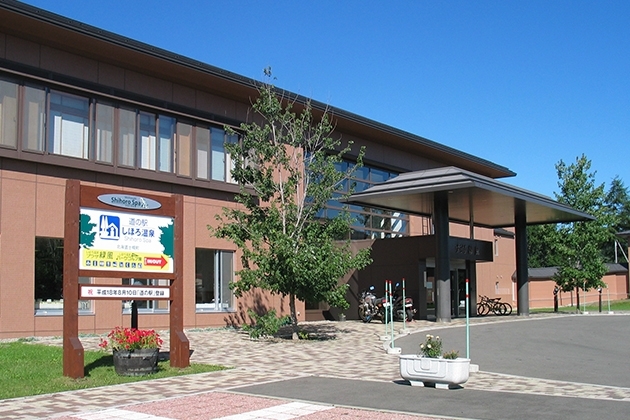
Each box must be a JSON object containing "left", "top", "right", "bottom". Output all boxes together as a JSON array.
[{"left": 0, "top": 315, "right": 630, "bottom": 420}]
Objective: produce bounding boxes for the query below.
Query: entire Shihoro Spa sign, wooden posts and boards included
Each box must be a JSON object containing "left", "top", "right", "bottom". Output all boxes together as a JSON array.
[{"left": 63, "top": 180, "right": 190, "bottom": 378}]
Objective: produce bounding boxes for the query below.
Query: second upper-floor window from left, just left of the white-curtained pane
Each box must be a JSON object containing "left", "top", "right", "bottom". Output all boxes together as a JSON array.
[{"left": 22, "top": 86, "right": 46, "bottom": 152}]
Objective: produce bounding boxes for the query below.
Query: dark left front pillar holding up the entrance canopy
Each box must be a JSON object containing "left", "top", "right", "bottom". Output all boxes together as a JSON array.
[{"left": 433, "top": 191, "right": 451, "bottom": 322}]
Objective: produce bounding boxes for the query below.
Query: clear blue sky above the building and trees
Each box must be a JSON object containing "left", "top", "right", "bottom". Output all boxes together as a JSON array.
[{"left": 26, "top": 0, "right": 630, "bottom": 197}]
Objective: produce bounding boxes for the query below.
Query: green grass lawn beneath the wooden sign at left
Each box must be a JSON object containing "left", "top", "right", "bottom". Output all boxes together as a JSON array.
[{"left": 0, "top": 341, "right": 225, "bottom": 399}]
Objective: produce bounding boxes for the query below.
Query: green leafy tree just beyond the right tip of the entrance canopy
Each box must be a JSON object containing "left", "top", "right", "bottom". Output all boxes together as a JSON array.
[{"left": 554, "top": 155, "right": 612, "bottom": 307}]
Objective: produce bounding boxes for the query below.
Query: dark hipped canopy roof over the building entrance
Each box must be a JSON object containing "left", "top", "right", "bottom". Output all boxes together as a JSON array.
[{"left": 345, "top": 166, "right": 594, "bottom": 228}]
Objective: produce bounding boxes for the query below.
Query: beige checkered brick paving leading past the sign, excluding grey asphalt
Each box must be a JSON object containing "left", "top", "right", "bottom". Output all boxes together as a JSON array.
[{"left": 0, "top": 315, "right": 630, "bottom": 419}]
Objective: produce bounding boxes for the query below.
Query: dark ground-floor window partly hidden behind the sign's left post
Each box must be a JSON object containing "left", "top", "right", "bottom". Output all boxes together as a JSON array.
[{"left": 35, "top": 237, "right": 92, "bottom": 315}]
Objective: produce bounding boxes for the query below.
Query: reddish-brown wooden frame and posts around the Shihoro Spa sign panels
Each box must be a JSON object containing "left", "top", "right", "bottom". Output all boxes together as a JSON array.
[{"left": 63, "top": 179, "right": 190, "bottom": 379}]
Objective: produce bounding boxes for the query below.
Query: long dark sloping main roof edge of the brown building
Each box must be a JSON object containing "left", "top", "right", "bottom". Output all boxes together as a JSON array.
[{"left": 0, "top": 0, "right": 516, "bottom": 178}]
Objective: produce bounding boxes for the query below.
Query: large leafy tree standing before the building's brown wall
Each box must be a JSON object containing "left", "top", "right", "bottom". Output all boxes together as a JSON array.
[{"left": 210, "top": 69, "right": 371, "bottom": 328}]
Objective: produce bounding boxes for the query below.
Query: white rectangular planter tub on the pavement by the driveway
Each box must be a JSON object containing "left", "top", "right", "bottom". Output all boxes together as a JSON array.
[{"left": 400, "top": 354, "right": 470, "bottom": 389}]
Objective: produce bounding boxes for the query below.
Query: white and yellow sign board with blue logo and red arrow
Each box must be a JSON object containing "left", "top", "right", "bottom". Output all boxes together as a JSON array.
[{"left": 79, "top": 208, "right": 175, "bottom": 274}]
